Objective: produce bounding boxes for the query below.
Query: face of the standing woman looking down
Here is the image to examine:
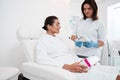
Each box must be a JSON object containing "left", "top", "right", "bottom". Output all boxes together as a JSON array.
[{"left": 83, "top": 4, "right": 93, "bottom": 18}]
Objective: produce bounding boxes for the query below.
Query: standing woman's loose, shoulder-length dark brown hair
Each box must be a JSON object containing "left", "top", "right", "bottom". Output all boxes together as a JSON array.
[{"left": 81, "top": 0, "right": 98, "bottom": 21}]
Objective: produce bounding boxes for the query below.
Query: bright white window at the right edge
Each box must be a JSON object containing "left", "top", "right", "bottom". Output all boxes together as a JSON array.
[{"left": 107, "top": 2, "right": 120, "bottom": 41}]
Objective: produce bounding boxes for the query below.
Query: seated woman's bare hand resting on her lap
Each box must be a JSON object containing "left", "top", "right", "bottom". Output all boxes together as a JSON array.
[{"left": 63, "top": 62, "right": 87, "bottom": 73}]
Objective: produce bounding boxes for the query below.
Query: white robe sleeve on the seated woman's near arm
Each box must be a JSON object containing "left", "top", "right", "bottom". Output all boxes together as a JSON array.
[{"left": 35, "top": 42, "right": 64, "bottom": 68}]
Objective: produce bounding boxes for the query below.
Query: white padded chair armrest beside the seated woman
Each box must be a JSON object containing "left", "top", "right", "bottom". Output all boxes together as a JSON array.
[{"left": 22, "top": 62, "right": 77, "bottom": 80}]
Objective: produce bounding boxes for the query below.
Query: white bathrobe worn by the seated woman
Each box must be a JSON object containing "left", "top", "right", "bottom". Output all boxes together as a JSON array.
[{"left": 35, "top": 34, "right": 118, "bottom": 80}]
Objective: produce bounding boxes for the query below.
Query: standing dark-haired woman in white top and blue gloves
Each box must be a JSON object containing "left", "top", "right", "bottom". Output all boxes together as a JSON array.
[{"left": 71, "top": 0, "right": 105, "bottom": 57}]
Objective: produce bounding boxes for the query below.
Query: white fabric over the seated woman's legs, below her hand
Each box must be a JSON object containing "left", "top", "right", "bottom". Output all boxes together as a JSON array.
[{"left": 77, "top": 65, "right": 120, "bottom": 80}]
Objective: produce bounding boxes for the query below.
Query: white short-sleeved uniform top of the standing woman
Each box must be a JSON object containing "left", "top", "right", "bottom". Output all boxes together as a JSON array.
[{"left": 72, "top": 18, "right": 105, "bottom": 56}]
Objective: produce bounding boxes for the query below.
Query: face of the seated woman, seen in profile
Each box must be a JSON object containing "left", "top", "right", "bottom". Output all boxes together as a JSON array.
[{"left": 49, "top": 19, "right": 60, "bottom": 35}]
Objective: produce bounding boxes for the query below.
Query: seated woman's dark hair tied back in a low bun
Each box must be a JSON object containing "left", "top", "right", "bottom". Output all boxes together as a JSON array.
[{"left": 42, "top": 16, "right": 58, "bottom": 31}]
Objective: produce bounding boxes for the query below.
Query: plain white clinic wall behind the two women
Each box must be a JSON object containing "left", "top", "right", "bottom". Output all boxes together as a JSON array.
[{"left": 0, "top": 0, "right": 120, "bottom": 68}]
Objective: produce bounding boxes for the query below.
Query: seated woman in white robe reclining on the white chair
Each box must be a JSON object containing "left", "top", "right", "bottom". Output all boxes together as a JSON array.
[{"left": 35, "top": 16, "right": 120, "bottom": 80}]
